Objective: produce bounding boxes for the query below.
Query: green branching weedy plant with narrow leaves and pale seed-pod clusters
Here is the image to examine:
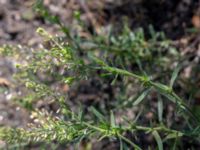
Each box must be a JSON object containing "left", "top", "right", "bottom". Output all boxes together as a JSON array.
[{"left": 0, "top": 1, "right": 200, "bottom": 150}]
